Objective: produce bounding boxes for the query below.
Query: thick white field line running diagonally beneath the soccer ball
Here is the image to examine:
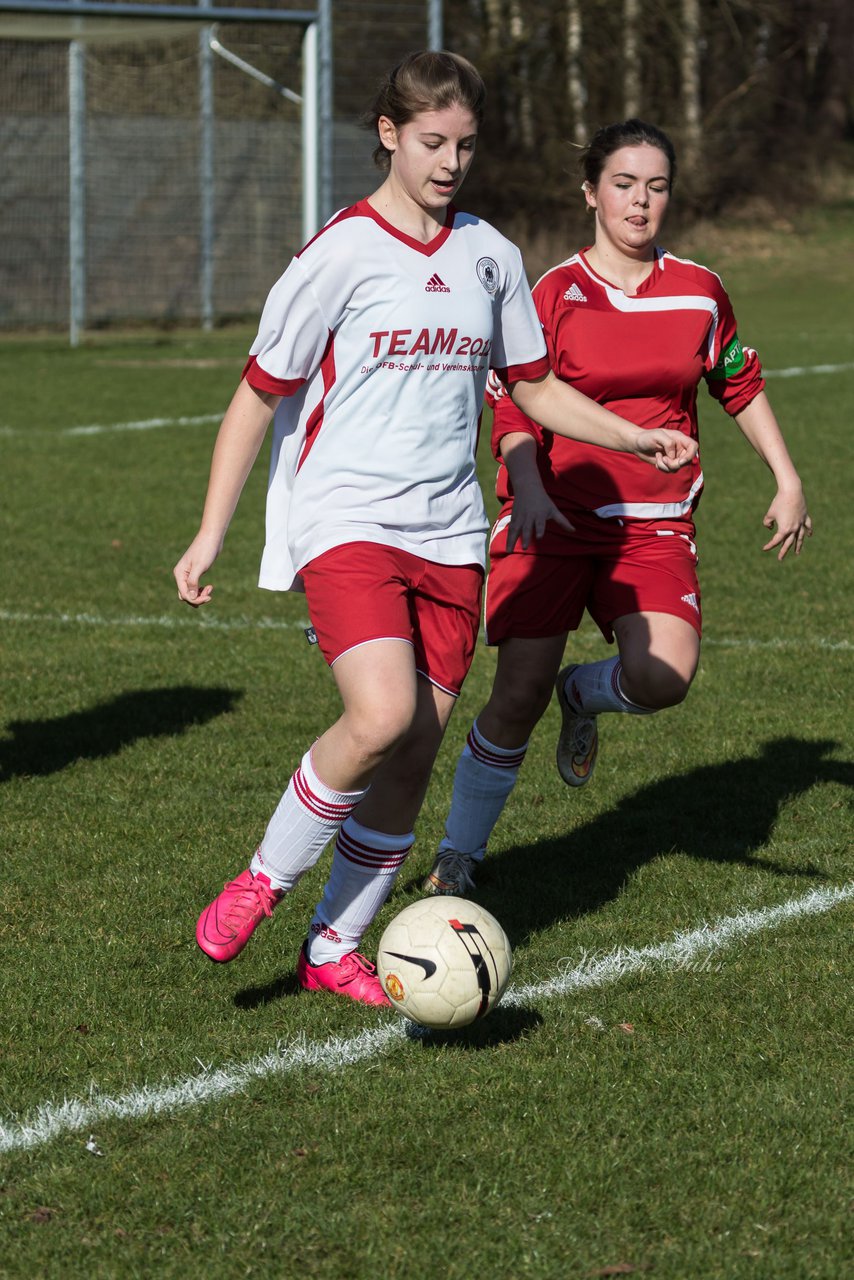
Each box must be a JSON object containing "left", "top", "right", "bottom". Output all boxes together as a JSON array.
[{"left": 0, "top": 881, "right": 854, "bottom": 1153}]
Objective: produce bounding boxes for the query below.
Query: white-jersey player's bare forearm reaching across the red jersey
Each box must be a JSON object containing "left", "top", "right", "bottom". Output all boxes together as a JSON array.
[{"left": 510, "top": 372, "right": 697, "bottom": 471}]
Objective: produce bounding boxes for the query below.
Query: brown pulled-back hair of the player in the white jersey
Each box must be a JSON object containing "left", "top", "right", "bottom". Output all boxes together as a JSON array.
[{"left": 362, "top": 50, "right": 487, "bottom": 169}]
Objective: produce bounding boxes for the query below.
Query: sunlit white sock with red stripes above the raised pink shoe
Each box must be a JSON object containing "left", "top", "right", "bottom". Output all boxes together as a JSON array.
[{"left": 250, "top": 751, "right": 365, "bottom": 891}]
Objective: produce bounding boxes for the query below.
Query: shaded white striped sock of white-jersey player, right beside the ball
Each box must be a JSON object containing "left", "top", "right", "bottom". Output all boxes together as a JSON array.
[{"left": 307, "top": 818, "right": 415, "bottom": 964}]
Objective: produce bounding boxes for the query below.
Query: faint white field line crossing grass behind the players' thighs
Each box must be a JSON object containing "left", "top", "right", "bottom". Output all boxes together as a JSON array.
[{"left": 0, "top": 609, "right": 854, "bottom": 653}]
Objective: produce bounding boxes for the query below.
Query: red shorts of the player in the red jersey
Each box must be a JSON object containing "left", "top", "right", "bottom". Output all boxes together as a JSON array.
[{"left": 485, "top": 507, "right": 702, "bottom": 644}]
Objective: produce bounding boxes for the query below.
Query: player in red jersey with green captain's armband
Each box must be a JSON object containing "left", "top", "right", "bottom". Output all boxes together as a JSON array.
[{"left": 424, "top": 119, "right": 812, "bottom": 893}]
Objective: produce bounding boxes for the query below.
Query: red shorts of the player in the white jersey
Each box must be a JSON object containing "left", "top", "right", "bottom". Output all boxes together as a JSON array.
[{"left": 300, "top": 543, "right": 483, "bottom": 696}]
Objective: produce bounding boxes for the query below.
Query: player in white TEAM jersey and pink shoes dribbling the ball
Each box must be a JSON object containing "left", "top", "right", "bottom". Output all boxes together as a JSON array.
[{"left": 174, "top": 52, "right": 694, "bottom": 1005}]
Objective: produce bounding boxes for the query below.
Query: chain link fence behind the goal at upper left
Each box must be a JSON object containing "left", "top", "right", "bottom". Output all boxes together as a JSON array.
[{"left": 0, "top": 0, "right": 429, "bottom": 330}]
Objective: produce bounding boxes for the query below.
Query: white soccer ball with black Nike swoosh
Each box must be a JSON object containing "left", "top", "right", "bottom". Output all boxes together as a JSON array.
[{"left": 376, "top": 896, "right": 513, "bottom": 1030}]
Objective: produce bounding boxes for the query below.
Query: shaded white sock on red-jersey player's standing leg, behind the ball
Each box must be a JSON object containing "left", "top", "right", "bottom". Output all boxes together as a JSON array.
[{"left": 439, "top": 721, "right": 528, "bottom": 861}]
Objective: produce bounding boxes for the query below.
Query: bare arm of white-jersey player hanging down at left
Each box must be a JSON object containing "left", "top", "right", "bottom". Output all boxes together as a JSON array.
[{"left": 173, "top": 380, "right": 282, "bottom": 608}]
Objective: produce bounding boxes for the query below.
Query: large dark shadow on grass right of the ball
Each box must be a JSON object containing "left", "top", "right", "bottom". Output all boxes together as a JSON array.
[{"left": 406, "top": 737, "right": 854, "bottom": 945}]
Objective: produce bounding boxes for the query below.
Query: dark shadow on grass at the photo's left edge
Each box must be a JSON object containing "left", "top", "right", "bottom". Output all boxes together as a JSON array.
[{"left": 0, "top": 685, "right": 243, "bottom": 782}]
